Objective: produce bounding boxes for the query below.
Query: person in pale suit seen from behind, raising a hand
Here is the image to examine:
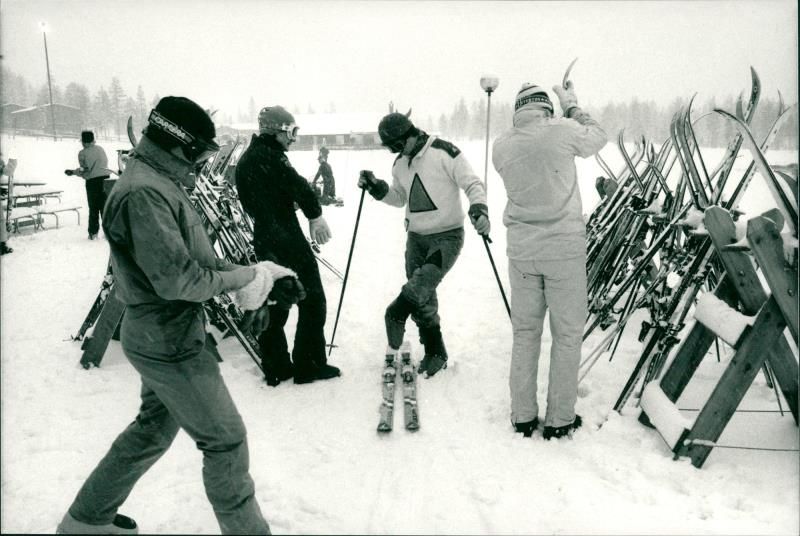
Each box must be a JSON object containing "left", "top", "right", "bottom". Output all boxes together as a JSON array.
[{"left": 492, "top": 82, "right": 606, "bottom": 439}]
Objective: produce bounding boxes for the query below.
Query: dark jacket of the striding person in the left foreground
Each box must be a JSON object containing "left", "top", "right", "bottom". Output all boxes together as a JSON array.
[{"left": 103, "top": 136, "right": 245, "bottom": 361}]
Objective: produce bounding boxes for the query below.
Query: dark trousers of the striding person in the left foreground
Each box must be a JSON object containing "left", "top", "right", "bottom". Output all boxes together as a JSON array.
[{"left": 69, "top": 342, "right": 270, "bottom": 534}]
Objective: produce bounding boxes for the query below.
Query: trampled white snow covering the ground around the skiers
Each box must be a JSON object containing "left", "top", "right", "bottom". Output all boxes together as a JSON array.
[{"left": 0, "top": 133, "right": 800, "bottom": 534}]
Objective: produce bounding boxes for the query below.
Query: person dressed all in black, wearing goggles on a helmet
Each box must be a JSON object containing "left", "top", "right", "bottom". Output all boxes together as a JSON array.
[{"left": 236, "top": 106, "right": 340, "bottom": 386}]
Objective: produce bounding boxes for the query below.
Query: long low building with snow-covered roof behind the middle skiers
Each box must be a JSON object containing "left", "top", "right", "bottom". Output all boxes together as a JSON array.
[{"left": 217, "top": 113, "right": 382, "bottom": 150}]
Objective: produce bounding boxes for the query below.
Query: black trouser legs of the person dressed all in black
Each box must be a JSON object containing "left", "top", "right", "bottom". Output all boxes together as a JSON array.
[{"left": 258, "top": 244, "right": 328, "bottom": 375}]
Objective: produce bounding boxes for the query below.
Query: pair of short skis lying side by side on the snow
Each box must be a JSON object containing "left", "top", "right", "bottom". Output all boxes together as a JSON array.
[{"left": 378, "top": 341, "right": 419, "bottom": 433}]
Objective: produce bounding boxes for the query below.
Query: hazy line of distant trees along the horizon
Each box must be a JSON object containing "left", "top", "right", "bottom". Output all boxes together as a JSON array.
[{"left": 0, "top": 67, "right": 798, "bottom": 149}]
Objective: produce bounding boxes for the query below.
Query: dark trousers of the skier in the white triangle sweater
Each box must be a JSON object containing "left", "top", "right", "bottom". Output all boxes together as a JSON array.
[{"left": 401, "top": 227, "right": 464, "bottom": 328}]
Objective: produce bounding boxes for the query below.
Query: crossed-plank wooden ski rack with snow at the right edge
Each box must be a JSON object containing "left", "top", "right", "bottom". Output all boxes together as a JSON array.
[{"left": 639, "top": 207, "right": 798, "bottom": 468}]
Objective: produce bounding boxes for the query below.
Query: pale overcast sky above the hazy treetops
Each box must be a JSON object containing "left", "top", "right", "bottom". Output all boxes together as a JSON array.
[{"left": 0, "top": 0, "right": 798, "bottom": 117}]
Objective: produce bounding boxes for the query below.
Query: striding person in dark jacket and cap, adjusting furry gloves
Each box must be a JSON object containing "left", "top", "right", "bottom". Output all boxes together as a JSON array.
[{"left": 57, "top": 97, "right": 286, "bottom": 534}]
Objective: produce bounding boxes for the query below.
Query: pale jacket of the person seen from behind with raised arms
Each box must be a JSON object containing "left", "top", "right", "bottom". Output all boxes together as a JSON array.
[{"left": 492, "top": 111, "right": 607, "bottom": 260}]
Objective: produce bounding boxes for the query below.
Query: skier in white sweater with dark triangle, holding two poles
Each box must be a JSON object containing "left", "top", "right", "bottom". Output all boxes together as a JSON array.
[{"left": 358, "top": 112, "right": 490, "bottom": 377}]
